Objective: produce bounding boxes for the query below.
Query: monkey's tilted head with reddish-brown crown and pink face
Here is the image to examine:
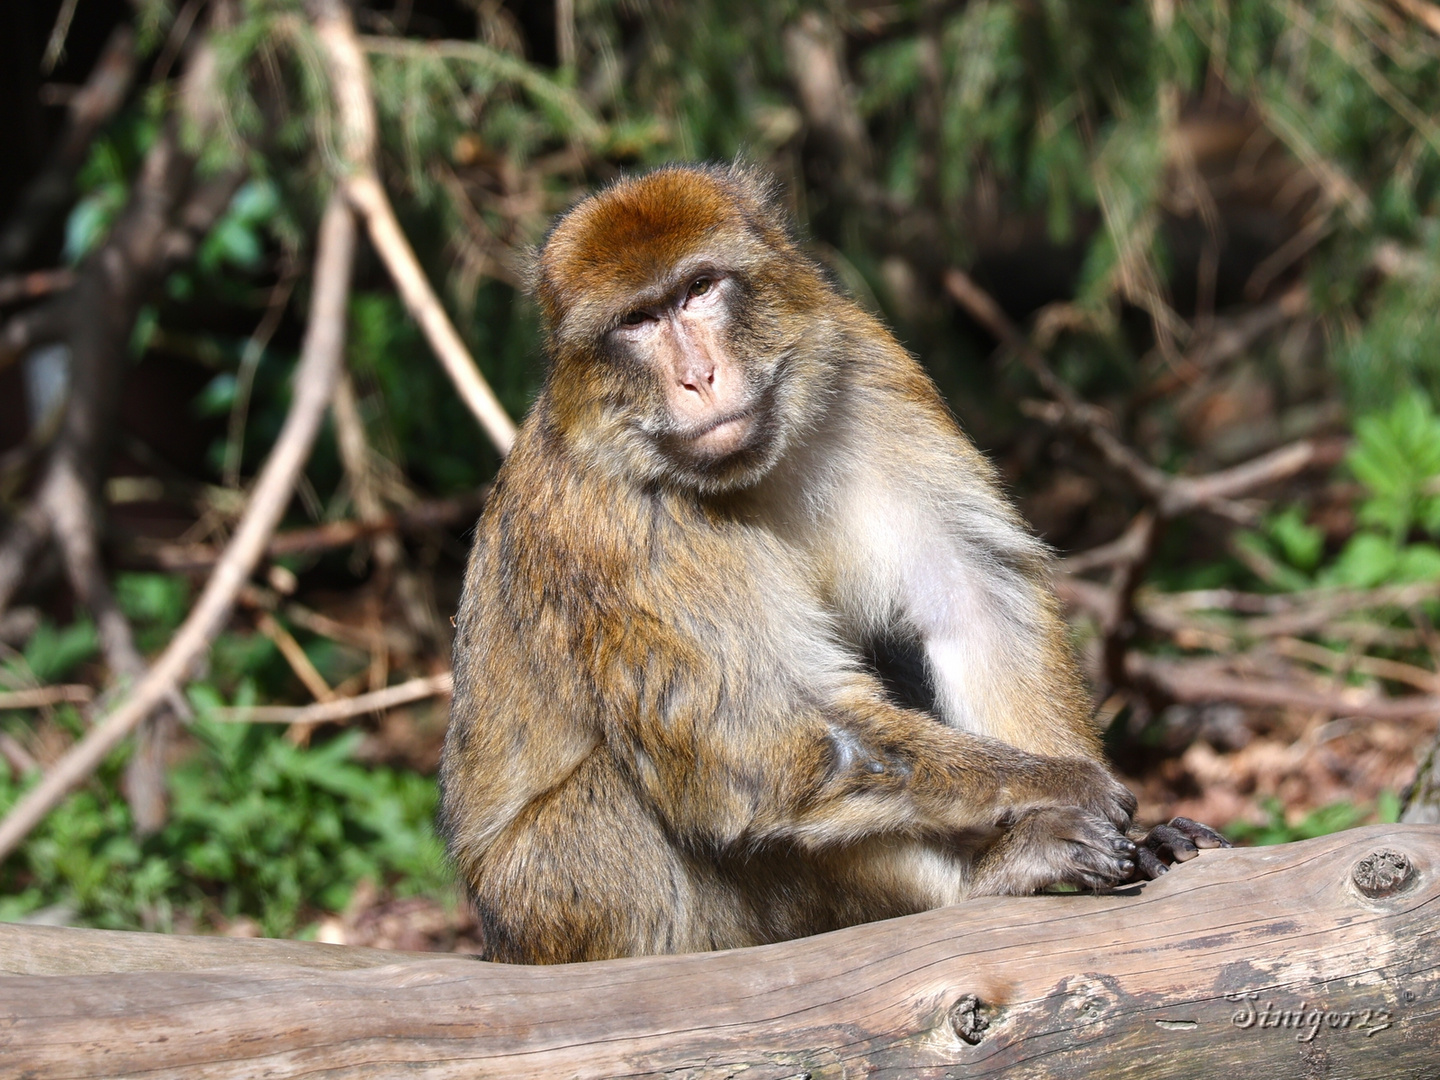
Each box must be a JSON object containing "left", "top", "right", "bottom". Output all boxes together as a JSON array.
[{"left": 536, "top": 167, "right": 835, "bottom": 494}]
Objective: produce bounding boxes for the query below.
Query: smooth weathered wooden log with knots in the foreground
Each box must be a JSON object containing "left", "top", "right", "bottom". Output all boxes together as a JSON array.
[{"left": 0, "top": 825, "right": 1440, "bottom": 1080}]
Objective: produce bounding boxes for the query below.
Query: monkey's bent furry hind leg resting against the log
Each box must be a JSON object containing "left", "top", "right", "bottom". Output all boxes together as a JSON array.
[{"left": 461, "top": 747, "right": 750, "bottom": 963}]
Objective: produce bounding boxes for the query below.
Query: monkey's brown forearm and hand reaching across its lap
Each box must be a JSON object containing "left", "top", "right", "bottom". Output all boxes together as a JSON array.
[{"left": 649, "top": 677, "right": 1135, "bottom": 883}]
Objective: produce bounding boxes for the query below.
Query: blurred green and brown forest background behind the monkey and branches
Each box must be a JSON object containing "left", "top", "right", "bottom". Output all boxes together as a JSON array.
[{"left": 0, "top": 0, "right": 1440, "bottom": 948}]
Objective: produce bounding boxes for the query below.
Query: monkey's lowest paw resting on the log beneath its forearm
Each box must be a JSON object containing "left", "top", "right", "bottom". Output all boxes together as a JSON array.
[{"left": 971, "top": 806, "right": 1138, "bottom": 896}]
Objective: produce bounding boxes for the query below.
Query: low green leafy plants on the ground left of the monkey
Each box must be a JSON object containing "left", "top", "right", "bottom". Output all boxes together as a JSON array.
[{"left": 0, "top": 688, "right": 448, "bottom": 936}]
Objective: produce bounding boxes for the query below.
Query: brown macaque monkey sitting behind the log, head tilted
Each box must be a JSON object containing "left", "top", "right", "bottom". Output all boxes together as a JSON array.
[{"left": 441, "top": 167, "right": 1223, "bottom": 963}]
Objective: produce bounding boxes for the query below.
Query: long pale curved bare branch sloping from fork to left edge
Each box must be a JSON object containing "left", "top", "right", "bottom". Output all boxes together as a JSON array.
[{"left": 0, "top": 194, "right": 356, "bottom": 858}]
